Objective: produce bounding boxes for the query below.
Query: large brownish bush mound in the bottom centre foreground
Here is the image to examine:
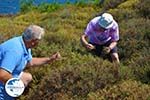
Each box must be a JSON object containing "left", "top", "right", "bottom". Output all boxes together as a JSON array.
[{"left": 26, "top": 58, "right": 117, "bottom": 100}]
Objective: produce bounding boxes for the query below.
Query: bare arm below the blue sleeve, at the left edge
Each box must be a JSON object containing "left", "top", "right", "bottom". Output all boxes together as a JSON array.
[{"left": 0, "top": 69, "right": 12, "bottom": 83}]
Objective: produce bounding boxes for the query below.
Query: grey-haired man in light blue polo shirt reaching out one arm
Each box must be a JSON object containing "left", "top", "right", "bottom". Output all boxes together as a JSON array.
[{"left": 0, "top": 25, "right": 60, "bottom": 100}]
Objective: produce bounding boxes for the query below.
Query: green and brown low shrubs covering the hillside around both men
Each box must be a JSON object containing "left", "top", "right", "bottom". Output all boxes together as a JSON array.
[{"left": 0, "top": 0, "right": 150, "bottom": 100}]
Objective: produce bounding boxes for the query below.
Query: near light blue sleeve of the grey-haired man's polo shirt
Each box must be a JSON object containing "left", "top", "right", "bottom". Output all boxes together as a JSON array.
[{"left": 0, "top": 51, "right": 19, "bottom": 73}]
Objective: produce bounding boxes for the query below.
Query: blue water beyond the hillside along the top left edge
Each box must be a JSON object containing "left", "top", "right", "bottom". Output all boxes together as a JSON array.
[{"left": 0, "top": 0, "right": 89, "bottom": 14}]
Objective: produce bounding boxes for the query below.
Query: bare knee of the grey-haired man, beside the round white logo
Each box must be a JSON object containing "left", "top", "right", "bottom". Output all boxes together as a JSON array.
[{"left": 20, "top": 72, "right": 32, "bottom": 86}]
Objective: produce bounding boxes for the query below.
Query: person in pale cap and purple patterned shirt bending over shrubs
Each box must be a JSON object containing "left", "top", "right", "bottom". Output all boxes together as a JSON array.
[{"left": 81, "top": 13, "right": 119, "bottom": 63}]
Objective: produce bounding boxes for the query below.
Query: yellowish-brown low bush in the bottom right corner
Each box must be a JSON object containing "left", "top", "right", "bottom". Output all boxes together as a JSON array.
[{"left": 87, "top": 80, "right": 150, "bottom": 100}]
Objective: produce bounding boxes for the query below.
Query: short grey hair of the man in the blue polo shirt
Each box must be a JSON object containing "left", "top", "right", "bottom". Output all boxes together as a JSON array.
[{"left": 23, "top": 25, "right": 45, "bottom": 41}]
